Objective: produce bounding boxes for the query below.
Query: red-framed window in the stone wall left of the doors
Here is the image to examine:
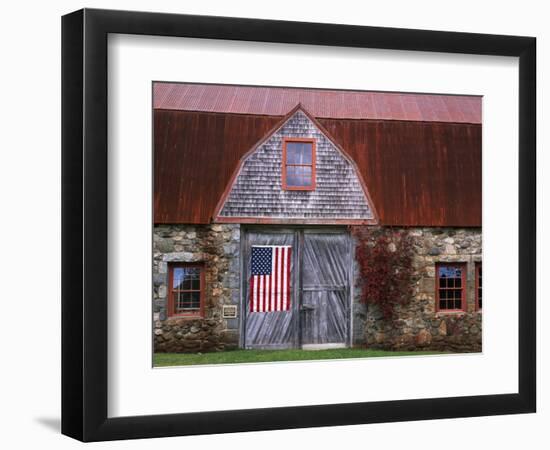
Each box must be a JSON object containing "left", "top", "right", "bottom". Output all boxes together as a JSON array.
[{"left": 168, "top": 263, "right": 205, "bottom": 317}]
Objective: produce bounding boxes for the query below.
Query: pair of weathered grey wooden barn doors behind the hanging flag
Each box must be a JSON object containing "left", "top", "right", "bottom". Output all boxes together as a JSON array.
[{"left": 242, "top": 229, "right": 351, "bottom": 349}]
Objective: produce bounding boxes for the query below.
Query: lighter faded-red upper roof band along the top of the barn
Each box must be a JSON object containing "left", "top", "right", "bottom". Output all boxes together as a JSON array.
[{"left": 153, "top": 82, "right": 481, "bottom": 124}]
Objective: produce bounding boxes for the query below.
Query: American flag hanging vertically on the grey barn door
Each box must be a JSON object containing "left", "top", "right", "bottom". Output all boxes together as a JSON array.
[{"left": 250, "top": 245, "right": 292, "bottom": 312}]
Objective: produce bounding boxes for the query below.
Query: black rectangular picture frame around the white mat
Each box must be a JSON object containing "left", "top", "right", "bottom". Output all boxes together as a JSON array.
[{"left": 62, "top": 9, "right": 536, "bottom": 441}]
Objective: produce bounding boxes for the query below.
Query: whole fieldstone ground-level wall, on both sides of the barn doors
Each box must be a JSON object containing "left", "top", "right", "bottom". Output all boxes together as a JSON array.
[{"left": 153, "top": 224, "right": 482, "bottom": 352}]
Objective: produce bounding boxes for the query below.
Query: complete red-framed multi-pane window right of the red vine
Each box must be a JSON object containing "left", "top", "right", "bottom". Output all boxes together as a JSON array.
[{"left": 435, "top": 263, "right": 466, "bottom": 311}]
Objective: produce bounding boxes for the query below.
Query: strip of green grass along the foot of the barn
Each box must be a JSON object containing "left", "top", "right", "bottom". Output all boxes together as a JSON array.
[{"left": 153, "top": 348, "right": 444, "bottom": 367}]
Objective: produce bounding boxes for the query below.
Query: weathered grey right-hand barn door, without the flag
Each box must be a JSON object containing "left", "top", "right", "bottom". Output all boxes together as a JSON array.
[{"left": 300, "top": 232, "right": 351, "bottom": 348}]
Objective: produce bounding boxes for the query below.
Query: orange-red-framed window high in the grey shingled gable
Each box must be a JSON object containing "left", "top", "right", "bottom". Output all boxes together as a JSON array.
[{"left": 282, "top": 138, "right": 315, "bottom": 191}]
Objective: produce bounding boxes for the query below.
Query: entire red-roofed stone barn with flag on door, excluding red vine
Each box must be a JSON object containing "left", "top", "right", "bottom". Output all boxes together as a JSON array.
[{"left": 153, "top": 82, "right": 482, "bottom": 352}]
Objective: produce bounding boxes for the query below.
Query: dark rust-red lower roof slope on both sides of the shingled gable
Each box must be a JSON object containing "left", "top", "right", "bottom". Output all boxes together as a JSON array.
[{"left": 154, "top": 110, "right": 482, "bottom": 227}]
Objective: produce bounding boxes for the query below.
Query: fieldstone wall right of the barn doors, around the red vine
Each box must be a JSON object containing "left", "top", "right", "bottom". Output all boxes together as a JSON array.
[{"left": 353, "top": 228, "right": 482, "bottom": 352}]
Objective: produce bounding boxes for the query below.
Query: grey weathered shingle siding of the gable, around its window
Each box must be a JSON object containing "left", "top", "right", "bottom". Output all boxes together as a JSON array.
[{"left": 219, "top": 110, "right": 374, "bottom": 220}]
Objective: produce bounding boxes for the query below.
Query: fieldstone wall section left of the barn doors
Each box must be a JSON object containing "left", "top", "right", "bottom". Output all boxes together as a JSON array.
[{"left": 153, "top": 225, "right": 240, "bottom": 352}]
